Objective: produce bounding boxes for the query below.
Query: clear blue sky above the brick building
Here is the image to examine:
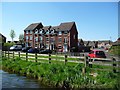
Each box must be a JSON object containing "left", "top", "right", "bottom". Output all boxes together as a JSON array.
[{"left": 2, "top": 2, "right": 118, "bottom": 41}]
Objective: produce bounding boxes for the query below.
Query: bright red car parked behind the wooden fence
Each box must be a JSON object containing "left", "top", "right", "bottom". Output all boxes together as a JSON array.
[{"left": 88, "top": 50, "right": 106, "bottom": 58}]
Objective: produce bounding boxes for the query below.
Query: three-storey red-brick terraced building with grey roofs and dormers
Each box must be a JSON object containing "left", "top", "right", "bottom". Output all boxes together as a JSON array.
[{"left": 24, "top": 22, "right": 78, "bottom": 52}]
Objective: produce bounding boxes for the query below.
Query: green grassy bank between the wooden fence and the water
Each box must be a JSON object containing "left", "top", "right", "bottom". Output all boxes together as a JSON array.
[{"left": 2, "top": 58, "right": 120, "bottom": 89}]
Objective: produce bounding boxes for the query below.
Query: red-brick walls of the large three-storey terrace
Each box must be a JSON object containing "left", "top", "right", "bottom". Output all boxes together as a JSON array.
[{"left": 24, "top": 24, "right": 78, "bottom": 52}]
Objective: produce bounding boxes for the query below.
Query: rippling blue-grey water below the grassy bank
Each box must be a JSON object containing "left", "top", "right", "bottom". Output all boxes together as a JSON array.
[{"left": 0, "top": 70, "right": 42, "bottom": 88}]
